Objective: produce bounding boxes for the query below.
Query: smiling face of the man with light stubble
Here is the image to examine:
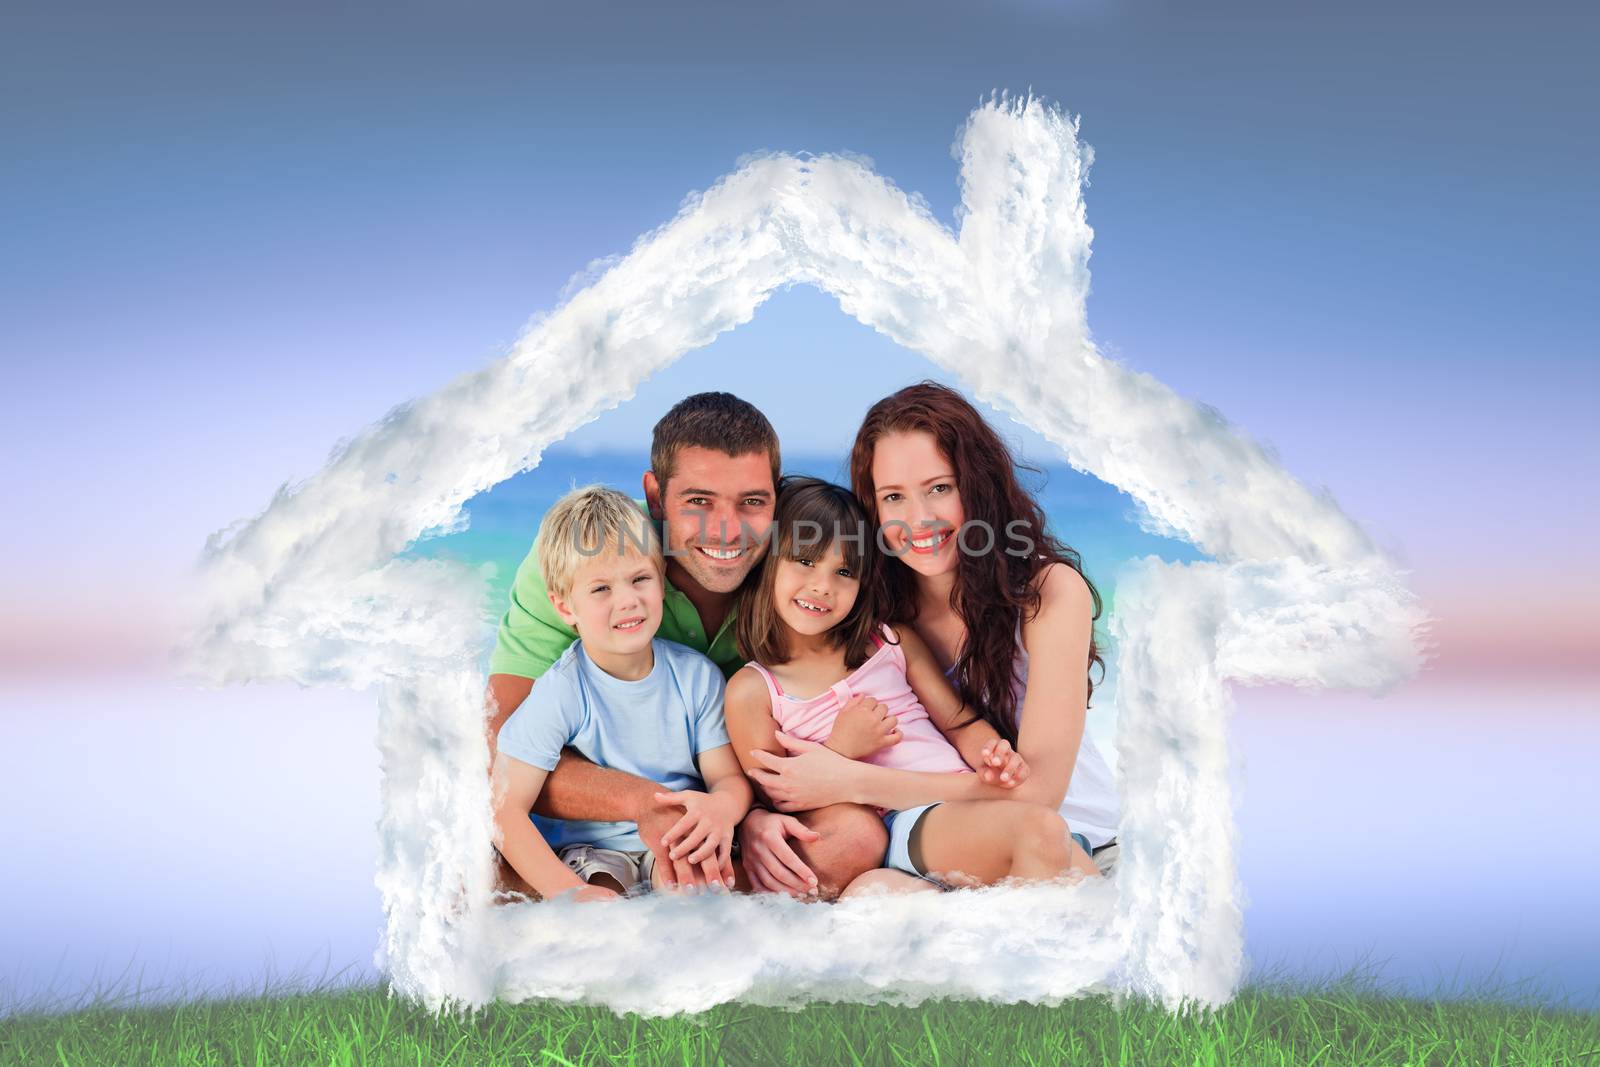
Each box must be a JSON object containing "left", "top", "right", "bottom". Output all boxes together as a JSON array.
[{"left": 645, "top": 445, "right": 778, "bottom": 593}]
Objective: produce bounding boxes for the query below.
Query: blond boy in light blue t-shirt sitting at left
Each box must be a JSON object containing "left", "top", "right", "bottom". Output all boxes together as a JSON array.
[{"left": 493, "top": 486, "right": 750, "bottom": 901}]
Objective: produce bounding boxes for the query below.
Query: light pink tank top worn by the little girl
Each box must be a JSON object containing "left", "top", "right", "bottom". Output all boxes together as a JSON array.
[{"left": 750, "top": 625, "right": 973, "bottom": 799}]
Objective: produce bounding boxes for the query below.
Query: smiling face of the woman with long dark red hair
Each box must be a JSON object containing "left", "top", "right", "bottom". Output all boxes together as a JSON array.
[{"left": 872, "top": 430, "right": 966, "bottom": 577}]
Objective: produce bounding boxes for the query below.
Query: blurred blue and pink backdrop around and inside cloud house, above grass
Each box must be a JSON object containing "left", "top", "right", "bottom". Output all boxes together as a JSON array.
[{"left": 0, "top": 0, "right": 1600, "bottom": 1005}]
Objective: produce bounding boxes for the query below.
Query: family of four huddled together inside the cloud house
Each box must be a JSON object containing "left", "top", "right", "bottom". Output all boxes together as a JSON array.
[{"left": 488, "top": 381, "right": 1118, "bottom": 901}]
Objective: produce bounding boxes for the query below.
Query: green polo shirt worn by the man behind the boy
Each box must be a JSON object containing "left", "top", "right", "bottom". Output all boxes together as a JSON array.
[{"left": 490, "top": 501, "right": 746, "bottom": 678}]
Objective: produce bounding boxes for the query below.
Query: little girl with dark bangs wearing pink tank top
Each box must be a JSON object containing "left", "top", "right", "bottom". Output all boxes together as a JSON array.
[{"left": 725, "top": 478, "right": 1096, "bottom": 894}]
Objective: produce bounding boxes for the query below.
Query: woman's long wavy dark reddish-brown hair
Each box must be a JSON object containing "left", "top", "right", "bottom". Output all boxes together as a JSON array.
[{"left": 850, "top": 381, "right": 1106, "bottom": 745}]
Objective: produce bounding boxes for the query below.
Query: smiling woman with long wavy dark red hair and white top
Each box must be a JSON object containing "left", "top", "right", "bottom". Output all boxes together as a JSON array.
[{"left": 746, "top": 382, "right": 1120, "bottom": 889}]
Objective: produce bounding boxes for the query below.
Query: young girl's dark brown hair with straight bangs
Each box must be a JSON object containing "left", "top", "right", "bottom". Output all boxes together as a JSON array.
[{"left": 734, "top": 475, "right": 880, "bottom": 670}]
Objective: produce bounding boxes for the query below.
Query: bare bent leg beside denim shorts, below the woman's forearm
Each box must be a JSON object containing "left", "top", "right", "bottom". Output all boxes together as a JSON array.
[{"left": 914, "top": 800, "right": 1096, "bottom": 885}]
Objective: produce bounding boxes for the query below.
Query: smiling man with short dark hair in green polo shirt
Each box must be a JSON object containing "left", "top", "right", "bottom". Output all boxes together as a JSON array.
[{"left": 488, "top": 392, "right": 886, "bottom": 899}]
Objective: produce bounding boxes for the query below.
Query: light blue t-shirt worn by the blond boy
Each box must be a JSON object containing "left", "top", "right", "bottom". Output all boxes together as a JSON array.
[{"left": 498, "top": 638, "right": 728, "bottom": 851}]
